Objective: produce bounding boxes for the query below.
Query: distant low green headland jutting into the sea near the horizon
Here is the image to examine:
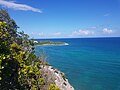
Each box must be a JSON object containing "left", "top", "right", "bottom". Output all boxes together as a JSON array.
[{"left": 34, "top": 41, "right": 65, "bottom": 45}]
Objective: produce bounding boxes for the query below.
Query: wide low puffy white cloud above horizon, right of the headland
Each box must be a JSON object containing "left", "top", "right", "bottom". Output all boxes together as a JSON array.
[{"left": 72, "top": 30, "right": 94, "bottom": 36}]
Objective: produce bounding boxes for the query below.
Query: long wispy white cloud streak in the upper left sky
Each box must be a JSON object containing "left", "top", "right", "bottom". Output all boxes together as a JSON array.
[{"left": 0, "top": 0, "right": 42, "bottom": 13}]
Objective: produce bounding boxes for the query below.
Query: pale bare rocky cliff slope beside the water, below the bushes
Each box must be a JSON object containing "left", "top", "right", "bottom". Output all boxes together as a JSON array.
[{"left": 42, "top": 65, "right": 74, "bottom": 90}]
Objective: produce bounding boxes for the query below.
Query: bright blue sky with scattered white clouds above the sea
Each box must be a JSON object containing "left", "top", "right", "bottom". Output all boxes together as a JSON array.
[{"left": 0, "top": 0, "right": 120, "bottom": 38}]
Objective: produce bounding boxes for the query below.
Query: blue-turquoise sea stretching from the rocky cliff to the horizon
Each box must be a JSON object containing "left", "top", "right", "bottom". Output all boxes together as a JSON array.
[{"left": 35, "top": 38, "right": 120, "bottom": 90}]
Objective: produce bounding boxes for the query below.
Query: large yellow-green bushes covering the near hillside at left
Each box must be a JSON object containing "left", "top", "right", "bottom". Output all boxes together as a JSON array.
[{"left": 0, "top": 10, "right": 60, "bottom": 90}]
